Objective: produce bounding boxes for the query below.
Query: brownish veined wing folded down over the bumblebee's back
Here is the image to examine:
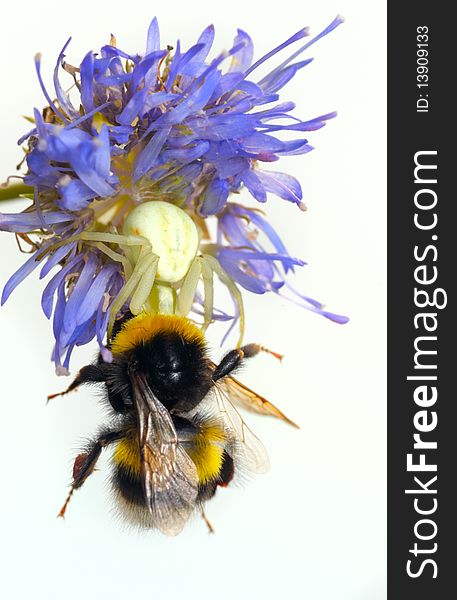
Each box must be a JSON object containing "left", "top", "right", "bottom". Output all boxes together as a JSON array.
[{"left": 130, "top": 372, "right": 198, "bottom": 535}]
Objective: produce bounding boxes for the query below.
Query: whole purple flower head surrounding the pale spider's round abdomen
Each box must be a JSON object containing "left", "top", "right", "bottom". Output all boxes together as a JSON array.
[{"left": 0, "top": 17, "right": 342, "bottom": 372}]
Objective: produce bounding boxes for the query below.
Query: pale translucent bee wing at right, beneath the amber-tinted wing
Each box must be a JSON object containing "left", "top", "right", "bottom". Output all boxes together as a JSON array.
[{"left": 214, "top": 383, "right": 270, "bottom": 473}]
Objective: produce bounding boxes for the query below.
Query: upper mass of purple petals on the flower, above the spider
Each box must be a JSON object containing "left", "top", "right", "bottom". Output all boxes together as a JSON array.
[{"left": 19, "top": 17, "right": 342, "bottom": 217}]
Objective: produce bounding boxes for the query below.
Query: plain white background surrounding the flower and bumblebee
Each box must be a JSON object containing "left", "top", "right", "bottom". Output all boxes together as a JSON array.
[{"left": 0, "top": 0, "right": 386, "bottom": 600}]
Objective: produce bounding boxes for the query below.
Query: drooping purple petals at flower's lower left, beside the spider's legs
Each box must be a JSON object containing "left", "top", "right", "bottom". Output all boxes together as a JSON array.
[{"left": 0, "top": 213, "right": 124, "bottom": 374}]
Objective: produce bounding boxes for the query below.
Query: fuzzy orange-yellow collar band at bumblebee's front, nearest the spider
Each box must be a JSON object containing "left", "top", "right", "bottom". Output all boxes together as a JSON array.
[{"left": 111, "top": 312, "right": 205, "bottom": 354}]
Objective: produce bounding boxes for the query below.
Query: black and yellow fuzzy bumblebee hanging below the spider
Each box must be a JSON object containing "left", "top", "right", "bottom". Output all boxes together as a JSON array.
[{"left": 50, "top": 313, "right": 294, "bottom": 535}]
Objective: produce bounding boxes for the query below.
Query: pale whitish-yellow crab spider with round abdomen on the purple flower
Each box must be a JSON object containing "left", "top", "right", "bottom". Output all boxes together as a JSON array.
[{"left": 39, "top": 200, "right": 244, "bottom": 345}]
